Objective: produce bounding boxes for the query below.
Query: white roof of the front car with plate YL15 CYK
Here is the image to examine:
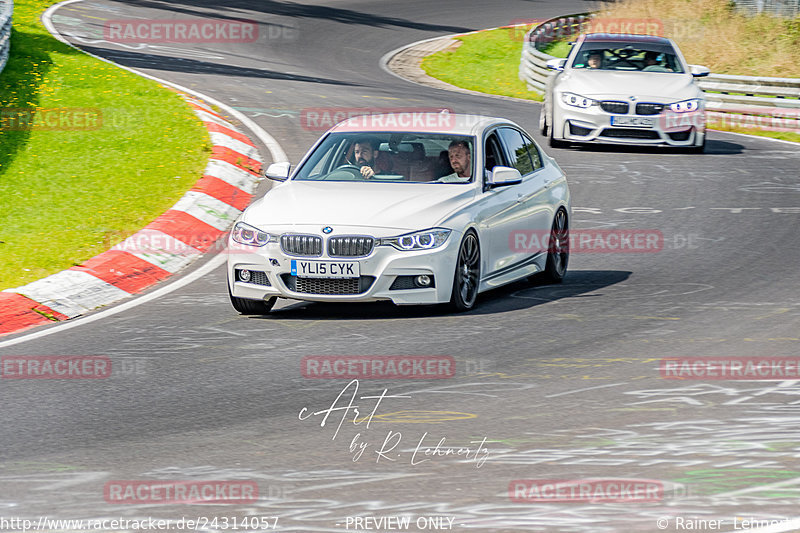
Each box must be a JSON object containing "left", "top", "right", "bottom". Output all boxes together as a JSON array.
[{"left": 328, "top": 111, "right": 500, "bottom": 135}]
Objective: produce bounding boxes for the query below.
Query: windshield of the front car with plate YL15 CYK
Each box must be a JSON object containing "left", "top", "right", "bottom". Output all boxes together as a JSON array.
[{"left": 294, "top": 132, "right": 475, "bottom": 183}]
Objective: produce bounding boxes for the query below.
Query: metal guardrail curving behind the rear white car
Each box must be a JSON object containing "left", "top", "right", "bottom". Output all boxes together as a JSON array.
[{"left": 519, "top": 14, "right": 800, "bottom": 132}]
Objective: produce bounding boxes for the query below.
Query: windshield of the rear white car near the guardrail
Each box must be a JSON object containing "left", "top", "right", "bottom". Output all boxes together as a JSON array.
[{"left": 572, "top": 41, "right": 683, "bottom": 74}]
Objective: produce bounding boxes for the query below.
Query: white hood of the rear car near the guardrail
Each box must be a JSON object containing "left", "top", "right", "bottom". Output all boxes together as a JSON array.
[{"left": 558, "top": 70, "right": 700, "bottom": 103}]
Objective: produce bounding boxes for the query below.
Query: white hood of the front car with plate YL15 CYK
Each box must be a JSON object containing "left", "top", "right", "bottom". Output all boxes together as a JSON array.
[{"left": 243, "top": 181, "right": 475, "bottom": 231}]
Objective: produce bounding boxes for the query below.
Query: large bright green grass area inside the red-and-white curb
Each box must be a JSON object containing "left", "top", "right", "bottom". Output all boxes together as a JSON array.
[{"left": 0, "top": 0, "right": 210, "bottom": 289}]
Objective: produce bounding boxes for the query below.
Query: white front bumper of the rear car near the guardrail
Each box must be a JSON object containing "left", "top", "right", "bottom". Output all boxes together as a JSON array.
[{"left": 553, "top": 102, "right": 705, "bottom": 147}]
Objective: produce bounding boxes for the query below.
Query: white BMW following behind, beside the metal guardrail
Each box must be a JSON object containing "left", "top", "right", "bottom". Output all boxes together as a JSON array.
[{"left": 539, "top": 33, "right": 709, "bottom": 152}]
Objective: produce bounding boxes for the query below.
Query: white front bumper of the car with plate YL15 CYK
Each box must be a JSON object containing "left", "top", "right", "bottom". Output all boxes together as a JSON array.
[{"left": 227, "top": 231, "right": 461, "bottom": 305}]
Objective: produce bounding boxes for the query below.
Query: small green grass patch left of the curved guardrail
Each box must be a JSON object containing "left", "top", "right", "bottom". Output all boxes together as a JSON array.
[{"left": 422, "top": 28, "right": 542, "bottom": 101}]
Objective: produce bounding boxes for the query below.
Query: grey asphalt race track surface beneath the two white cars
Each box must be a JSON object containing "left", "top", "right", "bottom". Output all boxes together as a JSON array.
[{"left": 0, "top": 0, "right": 800, "bottom": 533}]
